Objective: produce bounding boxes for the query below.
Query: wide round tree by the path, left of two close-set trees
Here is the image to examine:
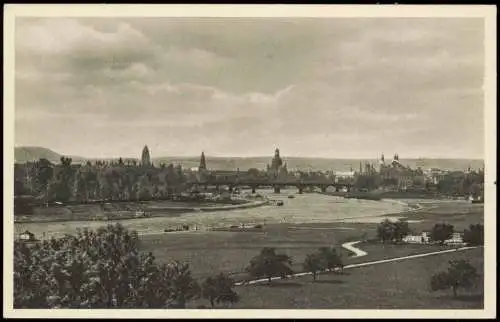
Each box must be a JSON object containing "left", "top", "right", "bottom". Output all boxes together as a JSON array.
[{"left": 246, "top": 247, "right": 293, "bottom": 283}]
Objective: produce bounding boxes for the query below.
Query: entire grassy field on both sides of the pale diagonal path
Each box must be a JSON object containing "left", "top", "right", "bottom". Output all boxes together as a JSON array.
[{"left": 141, "top": 201, "right": 484, "bottom": 309}]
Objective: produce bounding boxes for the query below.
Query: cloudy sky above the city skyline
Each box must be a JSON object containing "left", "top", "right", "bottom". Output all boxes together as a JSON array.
[{"left": 15, "top": 18, "right": 484, "bottom": 158}]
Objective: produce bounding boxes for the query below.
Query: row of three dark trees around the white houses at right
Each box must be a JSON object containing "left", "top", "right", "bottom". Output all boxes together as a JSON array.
[{"left": 377, "top": 219, "right": 484, "bottom": 246}]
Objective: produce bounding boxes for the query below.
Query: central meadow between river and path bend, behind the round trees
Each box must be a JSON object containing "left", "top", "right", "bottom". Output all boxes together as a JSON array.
[{"left": 141, "top": 225, "right": 359, "bottom": 278}]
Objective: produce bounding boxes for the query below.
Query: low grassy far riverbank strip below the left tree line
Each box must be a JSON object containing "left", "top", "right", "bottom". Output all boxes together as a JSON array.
[{"left": 14, "top": 199, "right": 269, "bottom": 223}]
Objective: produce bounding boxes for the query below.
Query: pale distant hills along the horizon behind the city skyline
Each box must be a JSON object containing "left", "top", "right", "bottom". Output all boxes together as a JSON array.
[{"left": 15, "top": 147, "right": 484, "bottom": 171}]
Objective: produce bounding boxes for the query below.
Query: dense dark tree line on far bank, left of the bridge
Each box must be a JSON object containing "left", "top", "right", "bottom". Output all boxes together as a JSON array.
[{"left": 14, "top": 157, "right": 190, "bottom": 202}]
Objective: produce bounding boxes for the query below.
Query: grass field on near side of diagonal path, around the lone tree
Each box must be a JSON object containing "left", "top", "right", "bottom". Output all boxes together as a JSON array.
[{"left": 199, "top": 248, "right": 483, "bottom": 309}]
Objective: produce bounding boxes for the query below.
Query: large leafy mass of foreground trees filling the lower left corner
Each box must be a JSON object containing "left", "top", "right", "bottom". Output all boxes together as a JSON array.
[{"left": 14, "top": 224, "right": 199, "bottom": 308}]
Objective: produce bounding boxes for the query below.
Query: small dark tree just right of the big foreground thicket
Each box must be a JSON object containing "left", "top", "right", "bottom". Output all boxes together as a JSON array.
[{"left": 201, "top": 273, "right": 239, "bottom": 308}]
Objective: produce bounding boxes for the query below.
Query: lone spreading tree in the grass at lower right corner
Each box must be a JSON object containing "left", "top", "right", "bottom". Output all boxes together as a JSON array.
[{"left": 431, "top": 259, "right": 479, "bottom": 297}]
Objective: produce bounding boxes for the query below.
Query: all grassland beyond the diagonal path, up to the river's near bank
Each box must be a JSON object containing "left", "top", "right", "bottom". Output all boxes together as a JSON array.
[{"left": 141, "top": 202, "right": 483, "bottom": 279}]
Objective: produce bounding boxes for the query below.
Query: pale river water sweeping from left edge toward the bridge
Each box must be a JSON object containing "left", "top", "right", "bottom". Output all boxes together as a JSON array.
[{"left": 15, "top": 189, "right": 409, "bottom": 237}]
